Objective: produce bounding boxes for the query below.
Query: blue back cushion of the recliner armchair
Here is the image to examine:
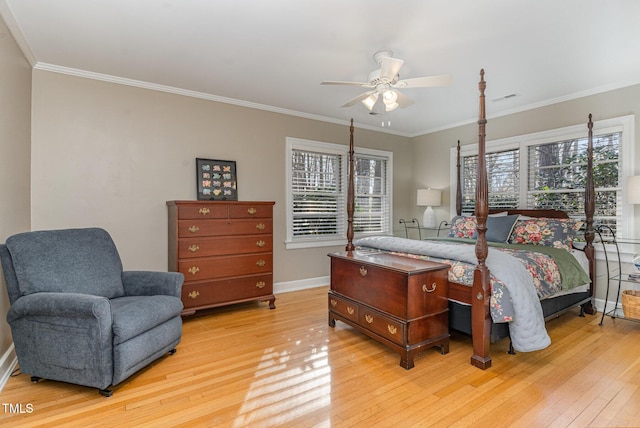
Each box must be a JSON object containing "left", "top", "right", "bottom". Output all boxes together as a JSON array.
[{"left": 6, "top": 228, "right": 124, "bottom": 299}]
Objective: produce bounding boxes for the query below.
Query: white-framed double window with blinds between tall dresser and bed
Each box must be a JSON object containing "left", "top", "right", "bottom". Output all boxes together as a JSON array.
[{"left": 286, "top": 138, "right": 393, "bottom": 248}]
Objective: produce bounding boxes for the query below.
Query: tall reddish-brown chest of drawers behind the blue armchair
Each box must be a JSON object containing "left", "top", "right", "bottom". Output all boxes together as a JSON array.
[{"left": 167, "top": 201, "right": 276, "bottom": 315}]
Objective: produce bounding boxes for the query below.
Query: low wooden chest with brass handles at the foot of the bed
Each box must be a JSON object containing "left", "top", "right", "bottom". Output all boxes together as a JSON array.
[{"left": 329, "top": 251, "right": 449, "bottom": 370}]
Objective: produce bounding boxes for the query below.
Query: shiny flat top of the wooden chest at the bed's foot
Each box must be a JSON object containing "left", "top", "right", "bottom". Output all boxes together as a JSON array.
[{"left": 329, "top": 250, "right": 449, "bottom": 275}]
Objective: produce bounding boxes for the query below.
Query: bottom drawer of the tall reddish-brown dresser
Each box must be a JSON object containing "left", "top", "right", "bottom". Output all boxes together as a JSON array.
[{"left": 182, "top": 274, "right": 273, "bottom": 309}]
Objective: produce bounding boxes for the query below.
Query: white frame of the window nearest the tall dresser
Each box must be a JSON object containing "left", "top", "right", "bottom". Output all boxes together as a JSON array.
[{"left": 285, "top": 137, "right": 393, "bottom": 250}]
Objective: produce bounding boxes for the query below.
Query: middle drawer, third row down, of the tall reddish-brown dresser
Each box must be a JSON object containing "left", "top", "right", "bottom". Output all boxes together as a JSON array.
[{"left": 178, "top": 235, "right": 273, "bottom": 259}]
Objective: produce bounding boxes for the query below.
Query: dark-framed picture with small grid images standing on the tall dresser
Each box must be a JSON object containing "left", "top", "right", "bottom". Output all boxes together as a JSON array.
[{"left": 196, "top": 158, "right": 238, "bottom": 201}]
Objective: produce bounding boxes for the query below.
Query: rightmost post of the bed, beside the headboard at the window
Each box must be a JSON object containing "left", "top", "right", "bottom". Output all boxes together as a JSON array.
[{"left": 582, "top": 114, "right": 596, "bottom": 315}]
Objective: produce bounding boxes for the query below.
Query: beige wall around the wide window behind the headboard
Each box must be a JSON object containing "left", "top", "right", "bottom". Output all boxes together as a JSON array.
[{"left": 411, "top": 81, "right": 640, "bottom": 299}]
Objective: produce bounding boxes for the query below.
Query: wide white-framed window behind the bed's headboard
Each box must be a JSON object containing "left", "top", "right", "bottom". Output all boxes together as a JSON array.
[{"left": 451, "top": 116, "right": 635, "bottom": 236}]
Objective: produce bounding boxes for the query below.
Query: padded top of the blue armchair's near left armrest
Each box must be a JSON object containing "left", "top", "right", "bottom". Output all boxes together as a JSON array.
[{"left": 7, "top": 293, "right": 111, "bottom": 326}]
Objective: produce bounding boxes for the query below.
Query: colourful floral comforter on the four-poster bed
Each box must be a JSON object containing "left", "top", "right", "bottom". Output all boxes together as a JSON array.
[{"left": 372, "top": 244, "right": 562, "bottom": 322}]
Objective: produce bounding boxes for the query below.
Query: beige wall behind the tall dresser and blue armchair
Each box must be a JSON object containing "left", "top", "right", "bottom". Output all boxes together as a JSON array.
[{"left": 31, "top": 70, "right": 412, "bottom": 283}]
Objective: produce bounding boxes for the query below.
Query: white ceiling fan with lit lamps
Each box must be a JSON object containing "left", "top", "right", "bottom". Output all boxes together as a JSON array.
[{"left": 321, "top": 50, "right": 451, "bottom": 114}]
